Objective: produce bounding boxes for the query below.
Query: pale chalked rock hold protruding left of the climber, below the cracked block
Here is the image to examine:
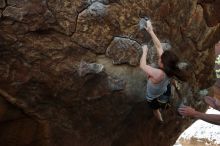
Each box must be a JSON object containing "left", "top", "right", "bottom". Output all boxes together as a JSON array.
[{"left": 78, "top": 61, "right": 104, "bottom": 77}]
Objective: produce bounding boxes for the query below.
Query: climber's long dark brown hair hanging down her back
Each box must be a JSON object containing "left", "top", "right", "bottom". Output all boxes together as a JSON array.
[{"left": 161, "top": 50, "right": 187, "bottom": 81}]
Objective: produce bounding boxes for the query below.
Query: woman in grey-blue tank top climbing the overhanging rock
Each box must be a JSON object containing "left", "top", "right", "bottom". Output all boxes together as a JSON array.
[{"left": 140, "top": 20, "right": 186, "bottom": 122}]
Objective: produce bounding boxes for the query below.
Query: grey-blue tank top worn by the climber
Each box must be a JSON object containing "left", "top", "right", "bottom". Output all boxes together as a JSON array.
[{"left": 147, "top": 74, "right": 170, "bottom": 99}]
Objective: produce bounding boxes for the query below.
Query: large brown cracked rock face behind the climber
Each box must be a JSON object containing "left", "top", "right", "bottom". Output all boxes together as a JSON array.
[{"left": 0, "top": 0, "right": 220, "bottom": 146}]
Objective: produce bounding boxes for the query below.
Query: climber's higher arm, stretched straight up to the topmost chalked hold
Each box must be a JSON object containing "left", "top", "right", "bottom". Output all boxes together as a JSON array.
[{"left": 145, "top": 24, "right": 163, "bottom": 56}]
